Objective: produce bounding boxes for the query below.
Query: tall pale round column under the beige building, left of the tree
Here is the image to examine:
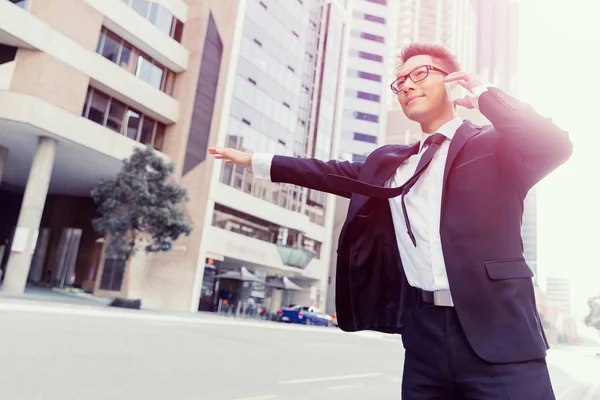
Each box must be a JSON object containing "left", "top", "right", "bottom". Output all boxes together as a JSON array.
[{"left": 2, "top": 137, "right": 57, "bottom": 294}]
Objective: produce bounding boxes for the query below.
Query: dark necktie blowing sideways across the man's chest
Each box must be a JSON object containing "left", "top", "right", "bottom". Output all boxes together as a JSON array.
[{"left": 328, "top": 133, "right": 447, "bottom": 247}]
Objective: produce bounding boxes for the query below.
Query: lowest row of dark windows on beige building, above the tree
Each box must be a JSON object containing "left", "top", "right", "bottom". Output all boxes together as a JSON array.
[{"left": 82, "top": 87, "right": 166, "bottom": 150}]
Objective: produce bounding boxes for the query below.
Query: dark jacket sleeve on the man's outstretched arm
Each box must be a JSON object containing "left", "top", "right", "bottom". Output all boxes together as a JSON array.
[{"left": 271, "top": 156, "right": 363, "bottom": 198}]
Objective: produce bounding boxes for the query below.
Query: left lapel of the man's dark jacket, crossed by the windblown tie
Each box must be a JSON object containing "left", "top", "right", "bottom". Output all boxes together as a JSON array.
[{"left": 347, "top": 143, "right": 419, "bottom": 221}]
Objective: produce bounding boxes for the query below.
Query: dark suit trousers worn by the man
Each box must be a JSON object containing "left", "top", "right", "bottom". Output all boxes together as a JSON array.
[{"left": 402, "top": 303, "right": 555, "bottom": 400}]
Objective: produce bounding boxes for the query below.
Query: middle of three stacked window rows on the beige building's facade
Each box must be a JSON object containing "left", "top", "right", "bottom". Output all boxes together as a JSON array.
[{"left": 96, "top": 28, "right": 175, "bottom": 94}]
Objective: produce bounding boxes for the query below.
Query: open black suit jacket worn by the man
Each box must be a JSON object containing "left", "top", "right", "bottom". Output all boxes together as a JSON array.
[{"left": 271, "top": 88, "right": 572, "bottom": 363}]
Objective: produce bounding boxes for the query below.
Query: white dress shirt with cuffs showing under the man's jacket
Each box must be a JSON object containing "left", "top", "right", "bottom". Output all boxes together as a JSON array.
[{"left": 252, "top": 85, "right": 490, "bottom": 291}]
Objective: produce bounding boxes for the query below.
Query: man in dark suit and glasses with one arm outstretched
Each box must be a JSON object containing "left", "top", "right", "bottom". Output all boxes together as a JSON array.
[{"left": 209, "top": 44, "right": 572, "bottom": 400}]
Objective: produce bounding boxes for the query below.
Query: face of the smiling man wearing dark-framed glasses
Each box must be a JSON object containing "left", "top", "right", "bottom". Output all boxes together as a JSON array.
[{"left": 397, "top": 55, "right": 452, "bottom": 123}]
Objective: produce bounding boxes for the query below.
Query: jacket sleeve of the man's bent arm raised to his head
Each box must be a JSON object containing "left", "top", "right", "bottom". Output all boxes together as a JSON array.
[{"left": 479, "top": 87, "right": 573, "bottom": 194}]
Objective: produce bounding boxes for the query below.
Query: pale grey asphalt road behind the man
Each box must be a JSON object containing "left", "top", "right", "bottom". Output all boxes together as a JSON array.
[{"left": 0, "top": 300, "right": 600, "bottom": 400}]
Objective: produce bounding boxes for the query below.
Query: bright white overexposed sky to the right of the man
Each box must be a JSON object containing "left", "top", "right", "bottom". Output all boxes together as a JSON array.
[{"left": 516, "top": 0, "right": 600, "bottom": 318}]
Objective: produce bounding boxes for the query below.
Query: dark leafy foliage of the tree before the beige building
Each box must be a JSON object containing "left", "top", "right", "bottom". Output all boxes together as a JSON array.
[{"left": 91, "top": 147, "right": 192, "bottom": 258}]
